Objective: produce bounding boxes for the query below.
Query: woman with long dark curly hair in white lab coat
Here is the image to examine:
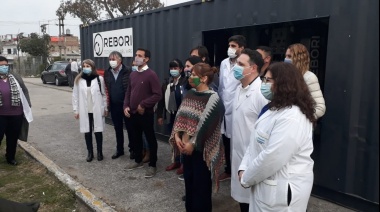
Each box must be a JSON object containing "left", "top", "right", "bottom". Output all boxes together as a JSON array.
[{"left": 238, "top": 62, "right": 316, "bottom": 212}]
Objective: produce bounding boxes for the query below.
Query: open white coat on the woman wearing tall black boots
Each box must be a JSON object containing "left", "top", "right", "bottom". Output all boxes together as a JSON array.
[{"left": 72, "top": 76, "right": 107, "bottom": 133}]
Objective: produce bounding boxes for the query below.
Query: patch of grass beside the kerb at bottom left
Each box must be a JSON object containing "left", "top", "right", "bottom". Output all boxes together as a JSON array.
[{"left": 0, "top": 141, "right": 88, "bottom": 212}]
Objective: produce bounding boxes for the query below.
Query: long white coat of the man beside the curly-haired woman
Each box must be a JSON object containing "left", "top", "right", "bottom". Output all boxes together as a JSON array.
[{"left": 231, "top": 78, "right": 268, "bottom": 203}]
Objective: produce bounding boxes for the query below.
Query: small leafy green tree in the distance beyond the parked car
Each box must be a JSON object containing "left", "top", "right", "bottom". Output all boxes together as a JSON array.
[{"left": 19, "top": 33, "right": 50, "bottom": 63}]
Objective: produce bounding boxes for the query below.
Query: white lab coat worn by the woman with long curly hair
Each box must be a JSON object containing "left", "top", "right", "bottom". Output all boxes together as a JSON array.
[{"left": 239, "top": 106, "right": 314, "bottom": 212}]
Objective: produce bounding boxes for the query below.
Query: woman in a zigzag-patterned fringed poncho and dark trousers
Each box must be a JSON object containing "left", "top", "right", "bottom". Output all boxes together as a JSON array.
[{"left": 169, "top": 63, "right": 224, "bottom": 212}]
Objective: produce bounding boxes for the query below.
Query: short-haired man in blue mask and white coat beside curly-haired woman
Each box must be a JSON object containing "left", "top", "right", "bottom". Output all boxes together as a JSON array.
[{"left": 231, "top": 49, "right": 268, "bottom": 212}]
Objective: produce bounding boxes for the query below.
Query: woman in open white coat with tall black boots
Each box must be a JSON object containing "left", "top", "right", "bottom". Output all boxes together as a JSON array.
[{"left": 72, "top": 59, "right": 108, "bottom": 162}]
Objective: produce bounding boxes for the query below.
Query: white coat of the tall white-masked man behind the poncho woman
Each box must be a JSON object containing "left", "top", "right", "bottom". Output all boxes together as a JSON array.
[{"left": 218, "top": 58, "right": 240, "bottom": 138}]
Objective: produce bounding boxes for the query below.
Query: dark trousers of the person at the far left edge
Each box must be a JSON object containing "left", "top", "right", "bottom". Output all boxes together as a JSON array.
[{"left": 0, "top": 115, "right": 24, "bottom": 161}]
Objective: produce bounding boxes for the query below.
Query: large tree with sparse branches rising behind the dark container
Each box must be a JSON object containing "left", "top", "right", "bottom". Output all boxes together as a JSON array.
[{"left": 57, "top": 0, "right": 164, "bottom": 25}]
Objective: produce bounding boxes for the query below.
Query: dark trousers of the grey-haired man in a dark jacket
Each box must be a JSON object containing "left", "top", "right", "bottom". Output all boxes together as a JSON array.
[{"left": 110, "top": 104, "right": 135, "bottom": 153}]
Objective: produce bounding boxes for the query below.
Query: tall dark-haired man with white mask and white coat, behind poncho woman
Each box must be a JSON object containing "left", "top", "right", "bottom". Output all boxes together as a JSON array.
[{"left": 218, "top": 35, "right": 247, "bottom": 181}]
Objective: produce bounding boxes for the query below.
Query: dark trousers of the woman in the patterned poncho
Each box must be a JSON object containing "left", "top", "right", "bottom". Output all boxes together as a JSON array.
[{"left": 183, "top": 151, "right": 212, "bottom": 212}]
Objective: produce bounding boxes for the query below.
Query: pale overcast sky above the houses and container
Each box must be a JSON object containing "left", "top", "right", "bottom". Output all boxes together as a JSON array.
[{"left": 0, "top": 0, "right": 191, "bottom": 37}]
